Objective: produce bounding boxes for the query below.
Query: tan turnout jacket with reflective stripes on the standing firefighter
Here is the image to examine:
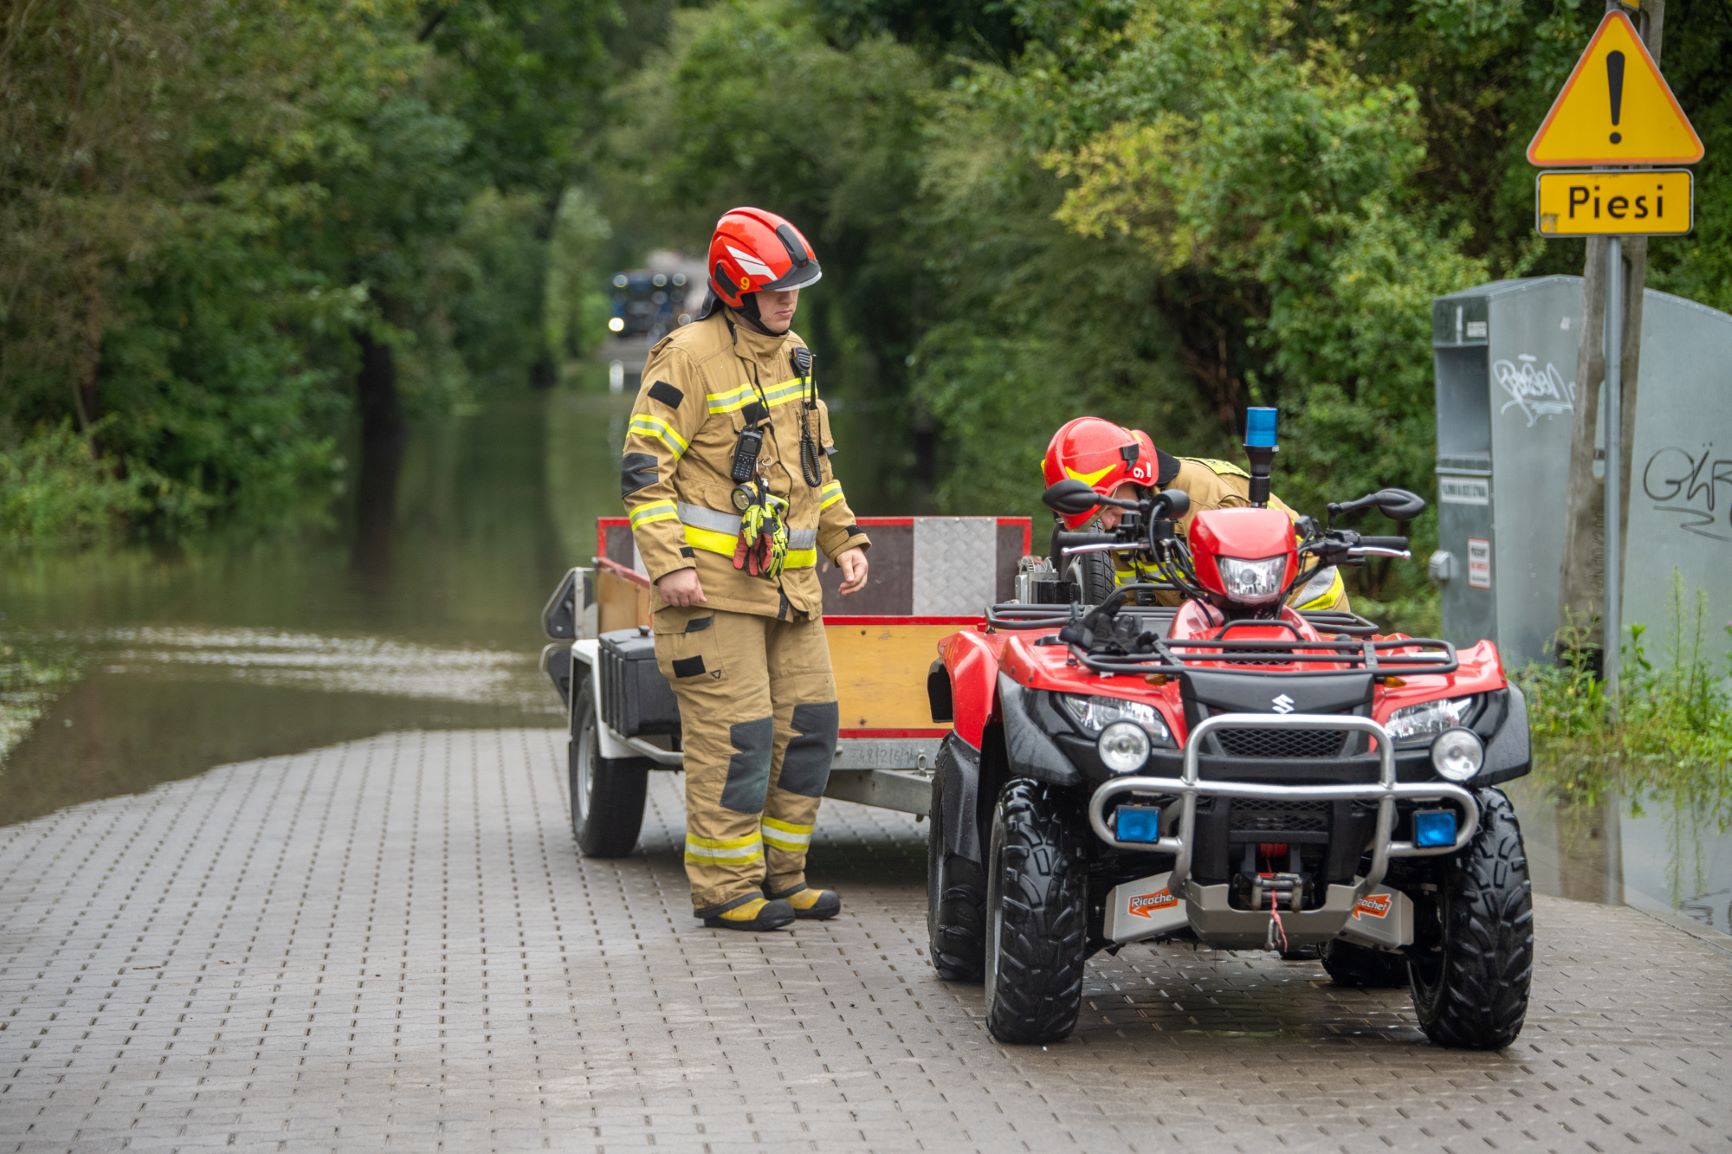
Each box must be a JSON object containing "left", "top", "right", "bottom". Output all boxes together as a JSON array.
[{"left": 620, "top": 308, "right": 869, "bottom": 617}]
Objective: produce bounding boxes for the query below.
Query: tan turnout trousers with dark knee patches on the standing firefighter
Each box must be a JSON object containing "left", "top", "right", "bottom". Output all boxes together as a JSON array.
[{"left": 653, "top": 605, "right": 837, "bottom": 917}]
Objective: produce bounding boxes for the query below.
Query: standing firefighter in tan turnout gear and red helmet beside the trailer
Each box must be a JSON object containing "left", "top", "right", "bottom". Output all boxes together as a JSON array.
[{"left": 620, "top": 208, "right": 869, "bottom": 930}]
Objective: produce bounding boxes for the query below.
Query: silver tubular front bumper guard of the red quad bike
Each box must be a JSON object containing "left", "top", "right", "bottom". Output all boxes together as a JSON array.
[{"left": 1088, "top": 714, "right": 1479, "bottom": 894}]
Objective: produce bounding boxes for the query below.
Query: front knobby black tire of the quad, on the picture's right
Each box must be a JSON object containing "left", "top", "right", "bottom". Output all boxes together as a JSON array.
[{"left": 1408, "top": 788, "right": 1533, "bottom": 1050}]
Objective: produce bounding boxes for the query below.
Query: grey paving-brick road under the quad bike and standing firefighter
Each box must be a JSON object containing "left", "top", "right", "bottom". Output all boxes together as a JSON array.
[{"left": 0, "top": 729, "right": 1732, "bottom": 1154}]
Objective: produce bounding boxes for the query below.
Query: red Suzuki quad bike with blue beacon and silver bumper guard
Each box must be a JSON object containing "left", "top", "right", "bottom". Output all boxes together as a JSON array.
[{"left": 927, "top": 409, "right": 1533, "bottom": 1050}]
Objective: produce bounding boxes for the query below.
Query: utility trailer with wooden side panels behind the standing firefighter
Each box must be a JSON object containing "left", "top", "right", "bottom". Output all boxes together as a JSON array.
[{"left": 540, "top": 516, "right": 1032, "bottom": 858}]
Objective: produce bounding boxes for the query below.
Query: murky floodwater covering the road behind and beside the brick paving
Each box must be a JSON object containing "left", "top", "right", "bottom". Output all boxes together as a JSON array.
[{"left": 0, "top": 348, "right": 1732, "bottom": 932}]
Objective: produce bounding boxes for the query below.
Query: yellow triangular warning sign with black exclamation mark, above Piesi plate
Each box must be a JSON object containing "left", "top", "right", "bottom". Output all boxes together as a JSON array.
[{"left": 1528, "top": 12, "right": 1703, "bottom": 168}]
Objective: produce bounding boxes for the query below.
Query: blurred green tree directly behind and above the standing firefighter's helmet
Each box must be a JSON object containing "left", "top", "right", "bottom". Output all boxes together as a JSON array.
[{"left": 604, "top": 0, "right": 930, "bottom": 443}]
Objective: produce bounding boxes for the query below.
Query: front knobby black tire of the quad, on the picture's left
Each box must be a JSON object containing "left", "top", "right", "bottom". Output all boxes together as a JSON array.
[{"left": 986, "top": 778, "right": 1088, "bottom": 1043}]
